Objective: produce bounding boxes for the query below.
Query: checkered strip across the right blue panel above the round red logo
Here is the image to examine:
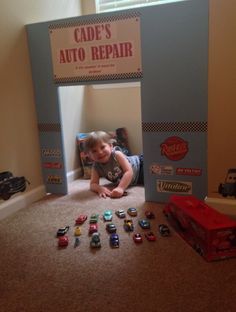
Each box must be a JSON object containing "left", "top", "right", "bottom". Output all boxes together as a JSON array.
[{"left": 142, "top": 121, "right": 207, "bottom": 132}]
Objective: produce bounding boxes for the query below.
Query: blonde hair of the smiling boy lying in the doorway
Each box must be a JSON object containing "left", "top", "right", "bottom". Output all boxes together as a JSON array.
[{"left": 84, "top": 131, "right": 114, "bottom": 153}]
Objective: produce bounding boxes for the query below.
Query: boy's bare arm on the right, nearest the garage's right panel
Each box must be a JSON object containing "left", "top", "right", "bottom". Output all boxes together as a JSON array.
[{"left": 111, "top": 151, "right": 133, "bottom": 197}]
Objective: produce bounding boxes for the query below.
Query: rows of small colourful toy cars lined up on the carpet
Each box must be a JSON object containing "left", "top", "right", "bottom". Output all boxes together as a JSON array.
[{"left": 57, "top": 207, "right": 170, "bottom": 248}]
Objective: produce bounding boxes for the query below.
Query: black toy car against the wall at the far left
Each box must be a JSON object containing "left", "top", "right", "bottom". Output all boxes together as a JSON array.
[{"left": 0, "top": 176, "right": 29, "bottom": 200}]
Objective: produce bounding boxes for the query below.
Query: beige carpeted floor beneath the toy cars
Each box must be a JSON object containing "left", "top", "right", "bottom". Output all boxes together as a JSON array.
[{"left": 0, "top": 180, "right": 236, "bottom": 312}]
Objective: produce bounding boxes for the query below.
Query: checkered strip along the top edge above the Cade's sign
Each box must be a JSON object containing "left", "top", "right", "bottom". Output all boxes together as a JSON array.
[{"left": 48, "top": 11, "right": 141, "bottom": 30}]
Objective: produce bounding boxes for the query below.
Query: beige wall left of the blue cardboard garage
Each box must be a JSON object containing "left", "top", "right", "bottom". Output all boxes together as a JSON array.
[{"left": 0, "top": 0, "right": 81, "bottom": 200}]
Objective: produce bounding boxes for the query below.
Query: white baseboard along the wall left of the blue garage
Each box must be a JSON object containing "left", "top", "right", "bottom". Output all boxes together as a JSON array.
[{"left": 0, "top": 185, "right": 46, "bottom": 220}]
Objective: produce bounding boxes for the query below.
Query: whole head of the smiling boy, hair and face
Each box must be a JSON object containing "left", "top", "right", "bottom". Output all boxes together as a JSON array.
[{"left": 84, "top": 131, "right": 113, "bottom": 163}]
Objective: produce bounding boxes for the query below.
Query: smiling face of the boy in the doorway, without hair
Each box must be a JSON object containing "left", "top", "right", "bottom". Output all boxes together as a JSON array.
[{"left": 88, "top": 142, "right": 112, "bottom": 164}]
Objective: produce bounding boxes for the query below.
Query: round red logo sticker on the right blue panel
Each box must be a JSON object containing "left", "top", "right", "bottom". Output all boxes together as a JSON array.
[{"left": 160, "top": 136, "right": 188, "bottom": 161}]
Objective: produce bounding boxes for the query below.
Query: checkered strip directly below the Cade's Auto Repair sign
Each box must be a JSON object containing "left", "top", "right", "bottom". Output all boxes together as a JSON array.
[{"left": 54, "top": 71, "right": 143, "bottom": 84}]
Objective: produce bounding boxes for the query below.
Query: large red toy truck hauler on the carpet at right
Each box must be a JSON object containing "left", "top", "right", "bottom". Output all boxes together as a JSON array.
[{"left": 163, "top": 195, "right": 236, "bottom": 261}]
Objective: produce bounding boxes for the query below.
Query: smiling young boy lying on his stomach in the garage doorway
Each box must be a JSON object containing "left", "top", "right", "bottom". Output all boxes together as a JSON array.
[{"left": 84, "top": 131, "right": 143, "bottom": 198}]
